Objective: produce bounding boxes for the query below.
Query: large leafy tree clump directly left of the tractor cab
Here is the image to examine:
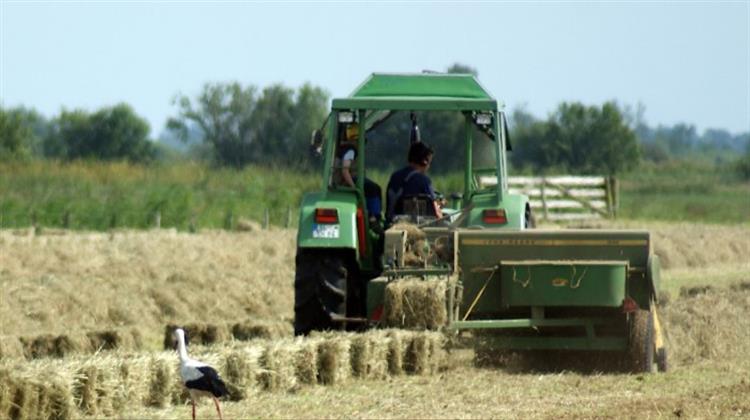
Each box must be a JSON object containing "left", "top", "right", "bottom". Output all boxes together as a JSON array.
[{"left": 167, "top": 82, "right": 328, "bottom": 167}]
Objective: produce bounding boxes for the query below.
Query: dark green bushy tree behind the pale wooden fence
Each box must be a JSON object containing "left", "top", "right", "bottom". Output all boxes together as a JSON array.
[{"left": 511, "top": 102, "right": 640, "bottom": 174}]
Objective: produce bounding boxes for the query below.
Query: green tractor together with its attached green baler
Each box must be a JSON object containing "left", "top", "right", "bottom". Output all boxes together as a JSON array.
[{"left": 294, "top": 74, "right": 667, "bottom": 372}]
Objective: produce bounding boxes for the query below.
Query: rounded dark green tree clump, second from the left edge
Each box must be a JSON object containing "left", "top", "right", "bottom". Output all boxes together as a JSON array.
[{"left": 44, "top": 103, "right": 155, "bottom": 162}]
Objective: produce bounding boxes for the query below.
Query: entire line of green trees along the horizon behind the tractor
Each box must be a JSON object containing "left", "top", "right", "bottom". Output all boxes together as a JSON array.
[{"left": 0, "top": 64, "right": 750, "bottom": 179}]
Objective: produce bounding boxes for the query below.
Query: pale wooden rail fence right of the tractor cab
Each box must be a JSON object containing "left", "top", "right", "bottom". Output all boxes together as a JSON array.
[{"left": 479, "top": 176, "right": 619, "bottom": 221}]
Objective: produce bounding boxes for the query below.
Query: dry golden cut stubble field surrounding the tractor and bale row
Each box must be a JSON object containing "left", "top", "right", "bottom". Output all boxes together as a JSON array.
[{"left": 0, "top": 222, "right": 750, "bottom": 419}]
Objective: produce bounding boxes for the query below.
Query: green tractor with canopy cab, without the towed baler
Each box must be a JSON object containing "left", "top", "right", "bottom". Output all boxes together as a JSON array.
[{"left": 297, "top": 73, "right": 530, "bottom": 333}]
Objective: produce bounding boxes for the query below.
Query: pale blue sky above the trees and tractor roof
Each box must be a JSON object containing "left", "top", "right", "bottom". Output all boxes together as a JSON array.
[{"left": 0, "top": 0, "right": 750, "bottom": 135}]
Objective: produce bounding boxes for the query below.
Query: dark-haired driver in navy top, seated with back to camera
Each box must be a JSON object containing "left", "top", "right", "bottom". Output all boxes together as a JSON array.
[{"left": 386, "top": 142, "right": 442, "bottom": 225}]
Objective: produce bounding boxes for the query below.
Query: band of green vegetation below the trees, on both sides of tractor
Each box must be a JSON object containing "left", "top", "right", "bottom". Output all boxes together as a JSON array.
[{"left": 0, "top": 161, "right": 750, "bottom": 230}]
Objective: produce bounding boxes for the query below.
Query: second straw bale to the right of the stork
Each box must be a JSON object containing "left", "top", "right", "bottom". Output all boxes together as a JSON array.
[{"left": 258, "top": 340, "right": 299, "bottom": 391}]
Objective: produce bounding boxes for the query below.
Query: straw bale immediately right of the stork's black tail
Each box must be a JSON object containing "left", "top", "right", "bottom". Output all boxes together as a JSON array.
[{"left": 222, "top": 346, "right": 264, "bottom": 401}]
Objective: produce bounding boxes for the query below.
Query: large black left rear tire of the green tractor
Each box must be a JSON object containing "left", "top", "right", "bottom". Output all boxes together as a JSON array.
[{"left": 294, "top": 252, "right": 348, "bottom": 335}]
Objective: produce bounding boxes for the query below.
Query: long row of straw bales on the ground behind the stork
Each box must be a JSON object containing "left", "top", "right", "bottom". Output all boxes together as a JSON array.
[{"left": 0, "top": 330, "right": 452, "bottom": 418}]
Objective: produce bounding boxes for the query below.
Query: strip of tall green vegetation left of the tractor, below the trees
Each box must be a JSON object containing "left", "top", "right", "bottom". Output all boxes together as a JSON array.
[{"left": 0, "top": 162, "right": 321, "bottom": 230}]
